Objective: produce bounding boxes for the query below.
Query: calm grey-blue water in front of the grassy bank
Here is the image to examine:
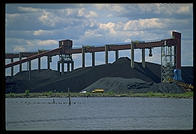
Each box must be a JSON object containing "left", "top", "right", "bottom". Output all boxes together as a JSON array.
[{"left": 5, "top": 97, "right": 193, "bottom": 130}]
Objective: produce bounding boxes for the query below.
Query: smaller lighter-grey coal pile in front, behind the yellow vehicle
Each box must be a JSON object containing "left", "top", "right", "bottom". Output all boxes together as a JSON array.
[{"left": 83, "top": 77, "right": 185, "bottom": 93}]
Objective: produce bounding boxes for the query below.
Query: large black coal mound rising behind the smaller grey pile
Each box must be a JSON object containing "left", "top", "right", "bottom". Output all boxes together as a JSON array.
[{"left": 5, "top": 57, "right": 193, "bottom": 93}]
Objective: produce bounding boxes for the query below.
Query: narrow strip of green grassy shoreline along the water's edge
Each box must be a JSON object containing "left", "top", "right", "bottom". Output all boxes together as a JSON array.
[{"left": 5, "top": 91, "right": 193, "bottom": 98}]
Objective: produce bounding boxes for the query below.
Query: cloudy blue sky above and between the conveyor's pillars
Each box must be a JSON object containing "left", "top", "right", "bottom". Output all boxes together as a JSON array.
[{"left": 5, "top": 3, "right": 193, "bottom": 75}]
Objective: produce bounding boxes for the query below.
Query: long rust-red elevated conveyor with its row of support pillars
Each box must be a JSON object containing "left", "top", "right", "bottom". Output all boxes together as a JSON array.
[{"left": 5, "top": 31, "right": 181, "bottom": 75}]
